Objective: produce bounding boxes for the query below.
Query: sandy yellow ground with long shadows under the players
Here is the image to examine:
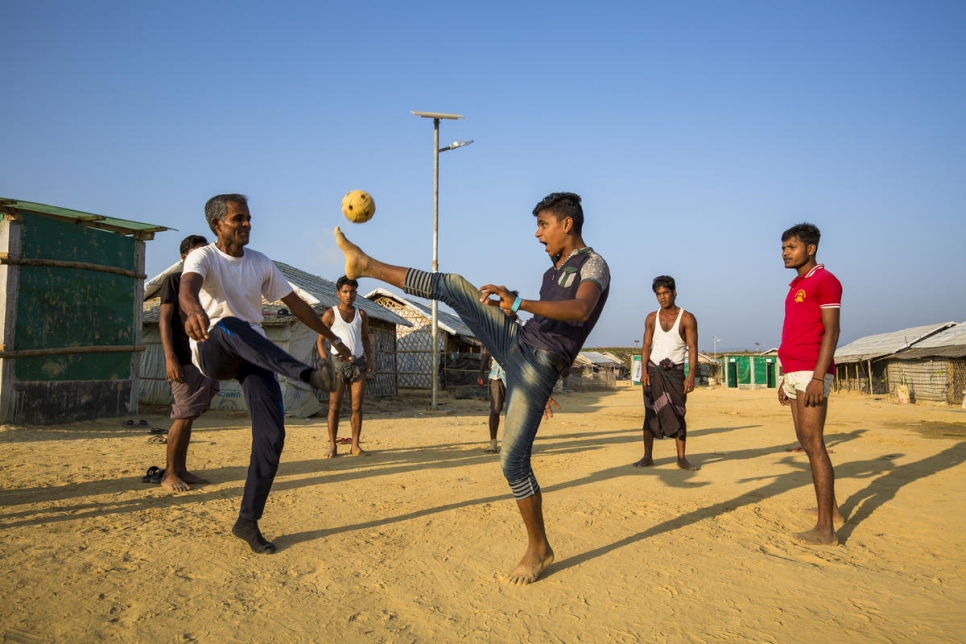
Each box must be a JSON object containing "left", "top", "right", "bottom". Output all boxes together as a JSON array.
[{"left": 0, "top": 384, "right": 966, "bottom": 643}]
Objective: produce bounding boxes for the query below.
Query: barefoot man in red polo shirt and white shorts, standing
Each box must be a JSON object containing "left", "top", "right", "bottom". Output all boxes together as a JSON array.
[{"left": 778, "top": 223, "right": 844, "bottom": 545}]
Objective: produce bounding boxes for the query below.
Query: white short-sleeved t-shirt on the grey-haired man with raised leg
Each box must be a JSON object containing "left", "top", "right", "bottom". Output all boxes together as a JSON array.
[{"left": 183, "top": 243, "right": 292, "bottom": 368}]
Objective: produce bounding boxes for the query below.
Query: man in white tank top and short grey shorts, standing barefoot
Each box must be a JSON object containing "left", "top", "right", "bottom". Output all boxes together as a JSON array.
[{"left": 316, "top": 275, "right": 374, "bottom": 458}]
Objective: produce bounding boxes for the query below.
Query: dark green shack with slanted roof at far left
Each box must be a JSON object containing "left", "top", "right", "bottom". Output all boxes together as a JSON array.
[{"left": 0, "top": 199, "right": 167, "bottom": 424}]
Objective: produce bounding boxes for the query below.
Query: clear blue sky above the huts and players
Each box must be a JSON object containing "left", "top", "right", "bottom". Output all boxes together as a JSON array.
[{"left": 0, "top": 0, "right": 966, "bottom": 352}]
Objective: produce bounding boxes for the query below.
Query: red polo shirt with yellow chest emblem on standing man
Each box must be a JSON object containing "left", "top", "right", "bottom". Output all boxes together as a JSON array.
[{"left": 778, "top": 264, "right": 842, "bottom": 374}]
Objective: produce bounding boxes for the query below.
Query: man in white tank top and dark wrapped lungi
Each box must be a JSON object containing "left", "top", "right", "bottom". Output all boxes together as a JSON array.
[{"left": 634, "top": 275, "right": 700, "bottom": 471}]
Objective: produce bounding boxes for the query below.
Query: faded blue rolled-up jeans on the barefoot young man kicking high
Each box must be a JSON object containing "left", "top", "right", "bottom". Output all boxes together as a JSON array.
[{"left": 405, "top": 269, "right": 559, "bottom": 500}]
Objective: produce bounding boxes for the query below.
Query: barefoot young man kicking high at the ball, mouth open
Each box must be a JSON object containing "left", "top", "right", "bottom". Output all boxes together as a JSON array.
[{"left": 335, "top": 192, "right": 610, "bottom": 584}]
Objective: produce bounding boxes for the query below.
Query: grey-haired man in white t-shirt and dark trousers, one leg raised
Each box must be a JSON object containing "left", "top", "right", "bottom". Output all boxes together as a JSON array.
[{"left": 179, "top": 194, "right": 350, "bottom": 553}]
